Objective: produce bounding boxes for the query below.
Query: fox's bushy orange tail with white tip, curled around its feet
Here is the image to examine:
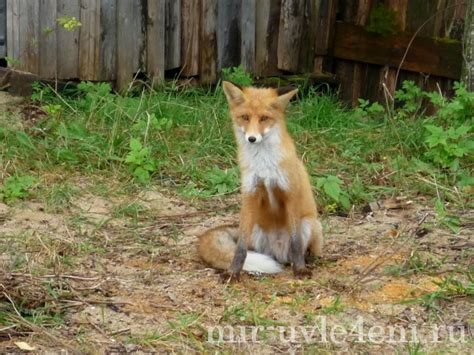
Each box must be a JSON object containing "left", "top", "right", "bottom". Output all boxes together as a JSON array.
[{"left": 198, "top": 226, "right": 282, "bottom": 274}]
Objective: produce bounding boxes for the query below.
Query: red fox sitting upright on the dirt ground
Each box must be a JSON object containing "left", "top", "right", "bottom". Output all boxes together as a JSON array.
[{"left": 198, "top": 81, "right": 323, "bottom": 277}]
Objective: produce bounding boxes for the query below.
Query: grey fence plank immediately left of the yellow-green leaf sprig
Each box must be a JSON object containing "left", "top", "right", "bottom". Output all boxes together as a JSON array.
[{"left": 39, "top": 0, "right": 57, "bottom": 79}]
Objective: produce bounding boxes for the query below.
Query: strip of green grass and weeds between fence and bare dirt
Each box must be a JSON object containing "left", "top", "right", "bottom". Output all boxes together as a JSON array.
[{"left": 0, "top": 79, "right": 472, "bottom": 214}]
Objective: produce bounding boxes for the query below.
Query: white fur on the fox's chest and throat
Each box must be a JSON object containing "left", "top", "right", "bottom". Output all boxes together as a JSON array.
[{"left": 236, "top": 127, "right": 289, "bottom": 200}]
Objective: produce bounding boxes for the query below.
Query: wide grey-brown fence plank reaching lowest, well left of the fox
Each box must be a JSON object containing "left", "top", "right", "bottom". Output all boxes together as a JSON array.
[{"left": 116, "top": 0, "right": 146, "bottom": 90}]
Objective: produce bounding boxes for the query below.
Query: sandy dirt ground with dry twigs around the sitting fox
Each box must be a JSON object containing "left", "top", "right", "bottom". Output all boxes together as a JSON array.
[{"left": 0, "top": 93, "right": 474, "bottom": 354}]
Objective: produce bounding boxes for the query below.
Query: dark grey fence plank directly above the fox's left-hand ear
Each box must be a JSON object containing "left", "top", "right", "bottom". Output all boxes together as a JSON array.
[{"left": 217, "top": 0, "right": 242, "bottom": 71}]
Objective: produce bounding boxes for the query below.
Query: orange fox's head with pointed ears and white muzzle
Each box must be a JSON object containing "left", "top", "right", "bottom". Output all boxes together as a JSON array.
[{"left": 223, "top": 81, "right": 298, "bottom": 144}]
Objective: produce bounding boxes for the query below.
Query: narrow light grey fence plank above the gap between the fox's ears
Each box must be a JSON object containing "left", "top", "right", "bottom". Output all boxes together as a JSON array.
[{"left": 241, "top": 0, "right": 257, "bottom": 73}]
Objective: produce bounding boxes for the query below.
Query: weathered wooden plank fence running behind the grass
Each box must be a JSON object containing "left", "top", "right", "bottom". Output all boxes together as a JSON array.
[{"left": 2, "top": 0, "right": 469, "bottom": 103}]
